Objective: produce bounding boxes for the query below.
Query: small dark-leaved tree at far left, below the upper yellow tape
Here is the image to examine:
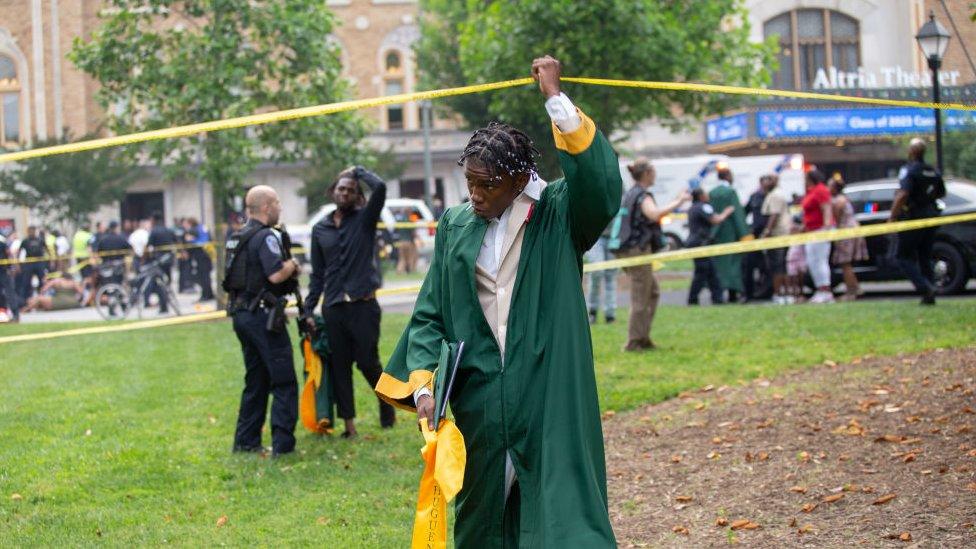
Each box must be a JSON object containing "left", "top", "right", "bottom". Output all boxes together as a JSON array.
[{"left": 0, "top": 135, "right": 140, "bottom": 231}]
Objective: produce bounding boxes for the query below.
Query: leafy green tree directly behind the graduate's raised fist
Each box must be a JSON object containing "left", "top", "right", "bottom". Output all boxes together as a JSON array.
[{"left": 417, "top": 0, "right": 775, "bottom": 175}]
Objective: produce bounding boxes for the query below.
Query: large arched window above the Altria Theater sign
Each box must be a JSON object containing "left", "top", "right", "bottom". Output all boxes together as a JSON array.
[{"left": 763, "top": 9, "right": 861, "bottom": 90}]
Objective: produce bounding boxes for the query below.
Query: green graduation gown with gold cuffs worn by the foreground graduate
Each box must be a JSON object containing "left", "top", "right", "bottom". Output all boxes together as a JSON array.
[{"left": 376, "top": 113, "right": 622, "bottom": 549}]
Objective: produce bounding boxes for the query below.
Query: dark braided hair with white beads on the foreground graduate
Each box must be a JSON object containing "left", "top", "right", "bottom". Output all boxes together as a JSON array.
[{"left": 458, "top": 122, "right": 539, "bottom": 181}]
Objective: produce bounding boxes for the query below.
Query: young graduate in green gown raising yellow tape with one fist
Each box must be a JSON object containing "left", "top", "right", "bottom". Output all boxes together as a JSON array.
[{"left": 376, "top": 56, "right": 622, "bottom": 549}]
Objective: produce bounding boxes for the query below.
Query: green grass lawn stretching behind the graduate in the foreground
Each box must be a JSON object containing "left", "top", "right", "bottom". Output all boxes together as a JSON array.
[{"left": 0, "top": 300, "right": 976, "bottom": 547}]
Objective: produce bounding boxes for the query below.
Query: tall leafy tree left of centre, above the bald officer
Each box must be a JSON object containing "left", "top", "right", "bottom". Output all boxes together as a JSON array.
[{"left": 71, "top": 0, "right": 368, "bottom": 222}]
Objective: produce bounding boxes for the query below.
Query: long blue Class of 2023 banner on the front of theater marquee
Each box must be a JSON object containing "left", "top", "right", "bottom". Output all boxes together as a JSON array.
[{"left": 756, "top": 107, "right": 976, "bottom": 138}]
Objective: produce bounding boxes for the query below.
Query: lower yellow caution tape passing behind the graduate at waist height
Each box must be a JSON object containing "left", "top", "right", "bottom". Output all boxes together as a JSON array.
[{"left": 0, "top": 213, "right": 976, "bottom": 344}]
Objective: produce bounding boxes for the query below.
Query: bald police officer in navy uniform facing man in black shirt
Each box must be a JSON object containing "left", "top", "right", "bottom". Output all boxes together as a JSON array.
[{"left": 223, "top": 185, "right": 300, "bottom": 457}]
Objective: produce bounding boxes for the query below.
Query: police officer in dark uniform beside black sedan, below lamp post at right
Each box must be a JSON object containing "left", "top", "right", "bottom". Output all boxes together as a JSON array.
[{"left": 889, "top": 137, "right": 945, "bottom": 305}]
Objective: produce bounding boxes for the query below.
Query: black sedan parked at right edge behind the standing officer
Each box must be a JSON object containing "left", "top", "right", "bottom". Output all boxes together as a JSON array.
[{"left": 833, "top": 179, "right": 976, "bottom": 294}]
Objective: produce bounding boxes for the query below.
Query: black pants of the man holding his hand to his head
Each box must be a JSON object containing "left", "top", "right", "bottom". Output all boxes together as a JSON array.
[{"left": 322, "top": 299, "right": 396, "bottom": 426}]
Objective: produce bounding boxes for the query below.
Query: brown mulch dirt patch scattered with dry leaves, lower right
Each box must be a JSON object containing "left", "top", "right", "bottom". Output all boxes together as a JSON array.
[{"left": 604, "top": 348, "right": 976, "bottom": 547}]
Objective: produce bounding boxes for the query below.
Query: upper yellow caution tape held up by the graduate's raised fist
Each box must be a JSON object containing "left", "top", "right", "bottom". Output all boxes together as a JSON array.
[{"left": 0, "top": 77, "right": 976, "bottom": 164}]
